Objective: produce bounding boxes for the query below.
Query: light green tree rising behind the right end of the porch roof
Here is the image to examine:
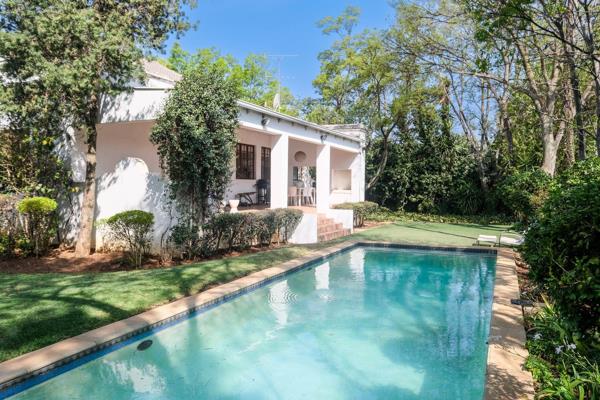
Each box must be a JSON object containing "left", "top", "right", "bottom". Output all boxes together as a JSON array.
[{"left": 313, "top": 8, "right": 430, "bottom": 189}]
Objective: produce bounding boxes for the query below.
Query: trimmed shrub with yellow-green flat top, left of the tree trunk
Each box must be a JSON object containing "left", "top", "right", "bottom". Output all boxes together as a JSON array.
[{"left": 17, "top": 197, "right": 58, "bottom": 257}]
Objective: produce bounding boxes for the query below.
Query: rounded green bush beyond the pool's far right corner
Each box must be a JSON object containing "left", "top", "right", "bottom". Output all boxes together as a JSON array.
[{"left": 498, "top": 168, "right": 552, "bottom": 225}]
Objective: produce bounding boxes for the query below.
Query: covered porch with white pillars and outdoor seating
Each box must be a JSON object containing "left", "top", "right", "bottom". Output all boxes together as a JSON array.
[{"left": 227, "top": 127, "right": 364, "bottom": 212}]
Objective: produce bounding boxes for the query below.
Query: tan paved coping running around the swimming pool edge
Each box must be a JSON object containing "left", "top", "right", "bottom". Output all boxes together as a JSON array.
[{"left": 0, "top": 241, "right": 533, "bottom": 400}]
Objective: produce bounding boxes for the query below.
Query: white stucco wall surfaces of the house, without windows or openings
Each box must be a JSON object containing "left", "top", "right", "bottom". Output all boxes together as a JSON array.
[{"left": 68, "top": 88, "right": 364, "bottom": 247}]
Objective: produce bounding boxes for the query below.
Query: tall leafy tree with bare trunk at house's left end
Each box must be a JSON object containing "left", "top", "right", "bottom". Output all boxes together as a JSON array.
[{"left": 0, "top": 0, "right": 194, "bottom": 255}]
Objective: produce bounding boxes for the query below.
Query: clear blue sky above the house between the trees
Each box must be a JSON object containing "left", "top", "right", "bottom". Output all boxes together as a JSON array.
[{"left": 168, "top": 0, "right": 394, "bottom": 97}]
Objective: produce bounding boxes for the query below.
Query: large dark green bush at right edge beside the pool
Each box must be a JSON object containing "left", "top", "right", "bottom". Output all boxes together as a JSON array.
[{"left": 522, "top": 158, "right": 600, "bottom": 342}]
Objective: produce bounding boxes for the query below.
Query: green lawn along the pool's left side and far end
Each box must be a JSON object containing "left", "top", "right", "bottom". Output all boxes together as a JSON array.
[{"left": 0, "top": 222, "right": 506, "bottom": 361}]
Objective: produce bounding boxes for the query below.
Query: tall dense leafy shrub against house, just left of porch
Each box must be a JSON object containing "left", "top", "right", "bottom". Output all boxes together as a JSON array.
[{"left": 150, "top": 65, "right": 239, "bottom": 230}]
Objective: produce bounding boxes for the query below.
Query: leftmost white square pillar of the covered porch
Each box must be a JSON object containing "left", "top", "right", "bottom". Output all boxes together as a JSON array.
[{"left": 271, "top": 135, "right": 289, "bottom": 208}]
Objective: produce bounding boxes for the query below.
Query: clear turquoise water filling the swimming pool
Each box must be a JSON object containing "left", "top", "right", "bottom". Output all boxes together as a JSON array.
[{"left": 9, "top": 247, "right": 496, "bottom": 400}]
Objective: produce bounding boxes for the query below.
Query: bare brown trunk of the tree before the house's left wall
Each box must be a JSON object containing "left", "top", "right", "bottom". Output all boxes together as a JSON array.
[{"left": 75, "top": 123, "right": 98, "bottom": 257}]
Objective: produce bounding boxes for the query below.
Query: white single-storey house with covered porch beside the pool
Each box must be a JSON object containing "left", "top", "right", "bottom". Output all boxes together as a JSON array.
[{"left": 65, "top": 62, "right": 365, "bottom": 247}]
